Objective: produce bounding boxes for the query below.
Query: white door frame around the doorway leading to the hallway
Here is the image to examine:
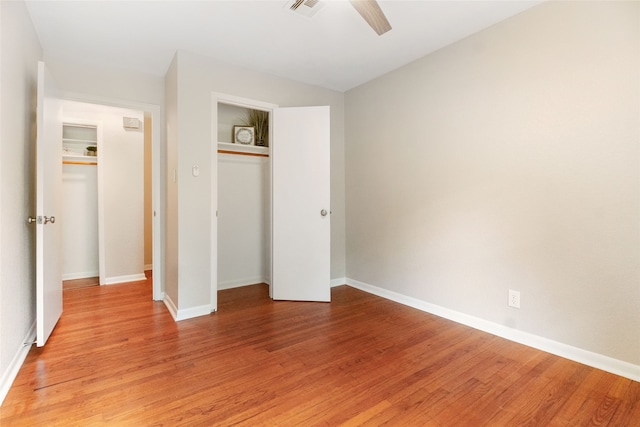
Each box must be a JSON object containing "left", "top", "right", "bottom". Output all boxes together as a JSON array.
[{"left": 61, "top": 92, "right": 165, "bottom": 301}]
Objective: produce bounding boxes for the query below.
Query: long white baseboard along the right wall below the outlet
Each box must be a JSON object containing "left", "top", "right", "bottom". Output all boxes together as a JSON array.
[{"left": 346, "top": 278, "right": 640, "bottom": 381}]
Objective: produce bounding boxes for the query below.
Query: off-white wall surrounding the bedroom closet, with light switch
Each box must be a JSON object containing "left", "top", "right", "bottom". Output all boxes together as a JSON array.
[{"left": 167, "top": 51, "right": 345, "bottom": 316}]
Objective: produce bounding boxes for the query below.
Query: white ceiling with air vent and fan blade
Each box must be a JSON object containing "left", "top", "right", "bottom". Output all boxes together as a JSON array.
[{"left": 26, "top": 0, "right": 542, "bottom": 91}]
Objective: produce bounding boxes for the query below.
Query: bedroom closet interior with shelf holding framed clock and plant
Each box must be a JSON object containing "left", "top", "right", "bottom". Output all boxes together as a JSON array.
[{"left": 216, "top": 100, "right": 271, "bottom": 300}]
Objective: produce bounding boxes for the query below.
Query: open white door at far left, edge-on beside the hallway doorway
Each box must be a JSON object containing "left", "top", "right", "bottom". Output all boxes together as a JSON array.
[{"left": 35, "top": 62, "right": 62, "bottom": 347}]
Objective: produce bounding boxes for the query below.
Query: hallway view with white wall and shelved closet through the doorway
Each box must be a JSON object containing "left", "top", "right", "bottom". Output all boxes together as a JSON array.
[{"left": 61, "top": 101, "right": 146, "bottom": 285}]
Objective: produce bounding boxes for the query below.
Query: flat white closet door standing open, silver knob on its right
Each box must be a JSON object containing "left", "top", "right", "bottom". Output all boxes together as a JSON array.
[{"left": 271, "top": 107, "right": 331, "bottom": 301}]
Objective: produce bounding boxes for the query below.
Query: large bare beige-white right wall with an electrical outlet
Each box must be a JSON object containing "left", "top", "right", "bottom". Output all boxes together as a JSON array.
[{"left": 345, "top": 2, "right": 640, "bottom": 365}]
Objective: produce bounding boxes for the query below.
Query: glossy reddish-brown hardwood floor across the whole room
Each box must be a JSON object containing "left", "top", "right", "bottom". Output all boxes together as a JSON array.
[{"left": 0, "top": 282, "right": 640, "bottom": 427}]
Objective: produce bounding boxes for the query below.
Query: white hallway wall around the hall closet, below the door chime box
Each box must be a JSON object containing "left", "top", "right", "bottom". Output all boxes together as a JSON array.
[{"left": 63, "top": 101, "right": 144, "bottom": 284}]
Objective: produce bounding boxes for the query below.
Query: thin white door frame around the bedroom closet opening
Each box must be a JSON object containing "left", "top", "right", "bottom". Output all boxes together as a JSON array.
[{"left": 210, "top": 92, "right": 278, "bottom": 312}]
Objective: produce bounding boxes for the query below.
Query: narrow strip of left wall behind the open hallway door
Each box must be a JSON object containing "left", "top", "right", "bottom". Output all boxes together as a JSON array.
[{"left": 0, "top": 1, "right": 42, "bottom": 402}]
